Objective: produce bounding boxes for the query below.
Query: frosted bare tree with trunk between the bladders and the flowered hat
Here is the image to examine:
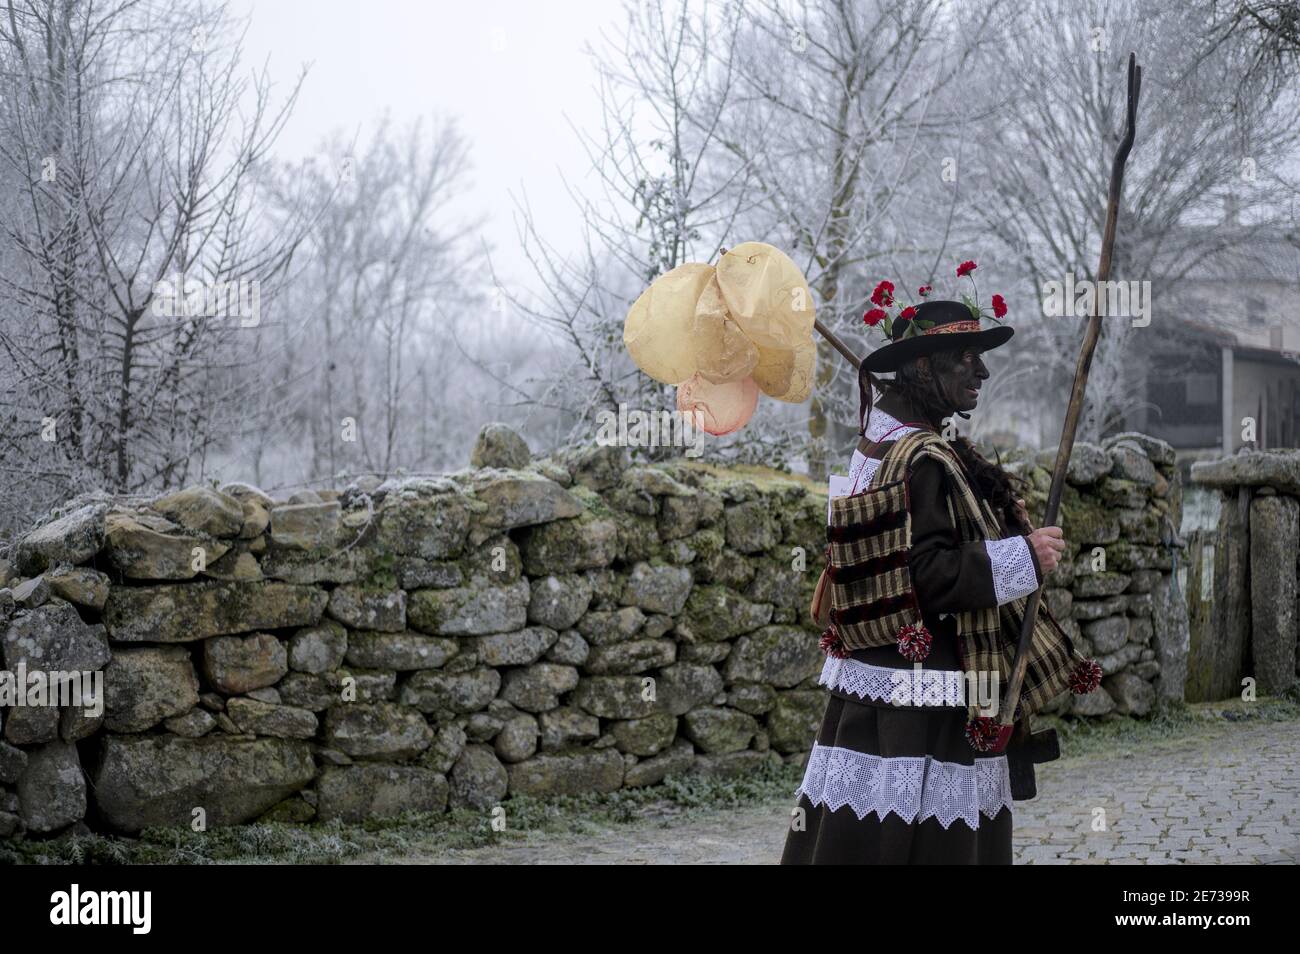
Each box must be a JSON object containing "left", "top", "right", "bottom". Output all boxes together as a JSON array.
[{"left": 696, "top": 0, "right": 1001, "bottom": 480}]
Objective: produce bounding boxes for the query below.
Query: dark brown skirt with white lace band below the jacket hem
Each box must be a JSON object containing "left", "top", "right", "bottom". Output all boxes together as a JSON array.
[{"left": 781, "top": 691, "right": 1011, "bottom": 864}]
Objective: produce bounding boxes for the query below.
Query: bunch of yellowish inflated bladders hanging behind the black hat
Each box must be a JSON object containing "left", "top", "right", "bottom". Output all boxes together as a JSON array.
[{"left": 623, "top": 242, "right": 816, "bottom": 410}]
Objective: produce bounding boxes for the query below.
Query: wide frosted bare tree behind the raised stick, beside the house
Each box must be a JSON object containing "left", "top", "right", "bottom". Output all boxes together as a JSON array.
[{"left": 962, "top": 0, "right": 1300, "bottom": 439}]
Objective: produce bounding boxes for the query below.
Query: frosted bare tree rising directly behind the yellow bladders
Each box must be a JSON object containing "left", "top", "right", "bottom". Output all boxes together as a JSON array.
[{"left": 494, "top": 0, "right": 754, "bottom": 462}]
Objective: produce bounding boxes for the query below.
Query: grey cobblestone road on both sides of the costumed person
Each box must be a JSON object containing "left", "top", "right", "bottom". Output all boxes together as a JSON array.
[{"left": 361, "top": 721, "right": 1300, "bottom": 864}]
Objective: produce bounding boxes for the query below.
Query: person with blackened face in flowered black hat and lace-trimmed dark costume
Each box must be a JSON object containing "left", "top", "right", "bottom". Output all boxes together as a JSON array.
[{"left": 781, "top": 300, "right": 1100, "bottom": 864}]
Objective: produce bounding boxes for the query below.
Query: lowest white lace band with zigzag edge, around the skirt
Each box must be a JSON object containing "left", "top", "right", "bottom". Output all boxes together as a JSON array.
[{"left": 794, "top": 742, "right": 1014, "bottom": 831}]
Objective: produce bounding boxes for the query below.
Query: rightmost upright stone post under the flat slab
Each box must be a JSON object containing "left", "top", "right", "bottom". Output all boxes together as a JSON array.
[{"left": 1251, "top": 490, "right": 1300, "bottom": 695}]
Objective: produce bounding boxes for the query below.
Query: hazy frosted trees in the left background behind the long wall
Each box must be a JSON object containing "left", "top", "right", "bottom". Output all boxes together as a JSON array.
[{"left": 250, "top": 120, "right": 484, "bottom": 483}]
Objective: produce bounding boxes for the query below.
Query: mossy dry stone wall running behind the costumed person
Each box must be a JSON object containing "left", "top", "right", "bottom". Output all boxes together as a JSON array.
[{"left": 0, "top": 425, "right": 1186, "bottom": 837}]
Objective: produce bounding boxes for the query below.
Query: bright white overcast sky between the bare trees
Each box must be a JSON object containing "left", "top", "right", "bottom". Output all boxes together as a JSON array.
[{"left": 231, "top": 0, "right": 623, "bottom": 291}]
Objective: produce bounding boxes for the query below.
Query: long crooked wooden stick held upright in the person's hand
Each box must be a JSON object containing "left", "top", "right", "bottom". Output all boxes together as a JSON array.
[{"left": 998, "top": 53, "right": 1141, "bottom": 725}]
